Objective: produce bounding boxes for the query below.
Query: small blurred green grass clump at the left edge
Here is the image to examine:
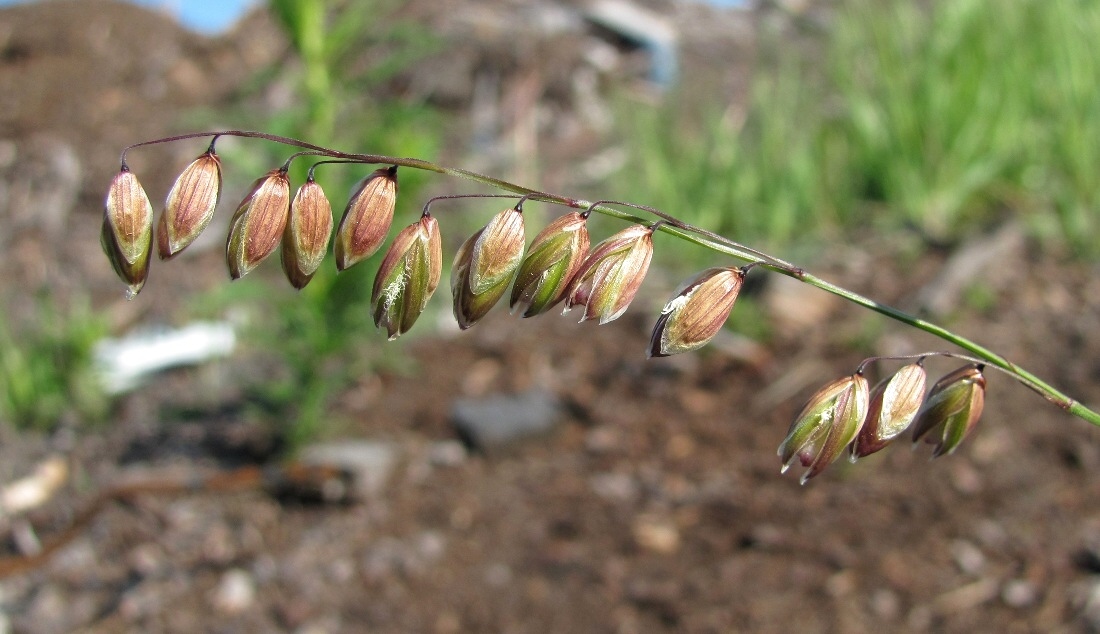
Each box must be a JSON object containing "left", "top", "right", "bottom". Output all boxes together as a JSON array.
[{"left": 0, "top": 295, "right": 109, "bottom": 431}]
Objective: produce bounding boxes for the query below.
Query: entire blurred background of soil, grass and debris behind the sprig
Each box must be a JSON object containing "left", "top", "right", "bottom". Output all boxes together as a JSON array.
[{"left": 0, "top": 0, "right": 1100, "bottom": 633}]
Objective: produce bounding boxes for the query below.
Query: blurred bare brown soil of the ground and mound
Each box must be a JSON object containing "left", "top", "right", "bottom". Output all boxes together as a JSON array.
[{"left": 0, "top": 0, "right": 1100, "bottom": 633}]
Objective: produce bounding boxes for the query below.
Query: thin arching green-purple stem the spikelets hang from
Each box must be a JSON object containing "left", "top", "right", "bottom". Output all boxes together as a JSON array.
[{"left": 122, "top": 130, "right": 1100, "bottom": 426}]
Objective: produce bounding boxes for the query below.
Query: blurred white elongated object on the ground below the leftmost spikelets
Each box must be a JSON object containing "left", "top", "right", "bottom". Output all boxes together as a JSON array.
[{"left": 95, "top": 321, "right": 237, "bottom": 394}]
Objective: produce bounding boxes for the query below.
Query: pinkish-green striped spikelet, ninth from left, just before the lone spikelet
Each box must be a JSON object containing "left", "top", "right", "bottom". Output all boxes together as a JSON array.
[{"left": 565, "top": 225, "right": 653, "bottom": 324}]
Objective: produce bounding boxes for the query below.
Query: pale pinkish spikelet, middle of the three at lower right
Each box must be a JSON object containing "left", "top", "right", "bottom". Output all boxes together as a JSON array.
[{"left": 850, "top": 362, "right": 927, "bottom": 461}]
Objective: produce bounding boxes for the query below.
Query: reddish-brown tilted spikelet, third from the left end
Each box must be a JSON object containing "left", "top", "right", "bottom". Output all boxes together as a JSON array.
[{"left": 226, "top": 170, "right": 290, "bottom": 280}]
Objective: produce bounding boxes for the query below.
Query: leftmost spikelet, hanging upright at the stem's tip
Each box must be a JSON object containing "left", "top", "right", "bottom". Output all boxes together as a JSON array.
[{"left": 100, "top": 165, "right": 153, "bottom": 297}]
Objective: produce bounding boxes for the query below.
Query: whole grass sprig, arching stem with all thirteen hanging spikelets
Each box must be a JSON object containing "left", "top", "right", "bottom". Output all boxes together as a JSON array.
[{"left": 103, "top": 130, "right": 1100, "bottom": 479}]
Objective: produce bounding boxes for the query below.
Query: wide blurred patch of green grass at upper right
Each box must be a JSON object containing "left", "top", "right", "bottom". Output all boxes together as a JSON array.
[{"left": 611, "top": 0, "right": 1100, "bottom": 256}]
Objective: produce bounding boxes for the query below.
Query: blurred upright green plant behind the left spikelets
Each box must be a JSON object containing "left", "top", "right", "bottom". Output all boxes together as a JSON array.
[{"left": 205, "top": 0, "right": 441, "bottom": 451}]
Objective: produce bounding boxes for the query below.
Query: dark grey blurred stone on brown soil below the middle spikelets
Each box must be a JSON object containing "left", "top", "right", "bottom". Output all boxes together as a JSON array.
[{"left": 451, "top": 389, "right": 561, "bottom": 451}]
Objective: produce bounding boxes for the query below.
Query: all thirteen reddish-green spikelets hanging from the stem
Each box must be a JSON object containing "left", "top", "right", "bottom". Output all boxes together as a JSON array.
[{"left": 101, "top": 138, "right": 1003, "bottom": 482}]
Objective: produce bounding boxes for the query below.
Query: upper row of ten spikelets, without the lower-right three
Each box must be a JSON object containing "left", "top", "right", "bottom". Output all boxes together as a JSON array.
[{"left": 109, "top": 143, "right": 686, "bottom": 339}]
